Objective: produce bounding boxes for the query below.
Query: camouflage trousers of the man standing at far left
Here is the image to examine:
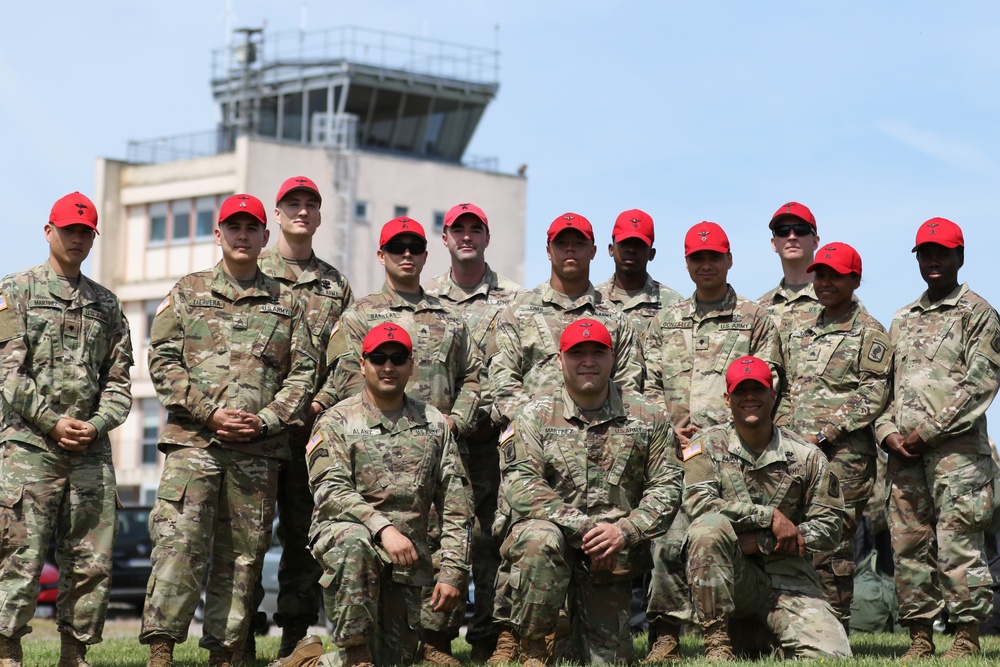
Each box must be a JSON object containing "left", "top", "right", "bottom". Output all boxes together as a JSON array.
[{"left": 0, "top": 441, "right": 118, "bottom": 644}]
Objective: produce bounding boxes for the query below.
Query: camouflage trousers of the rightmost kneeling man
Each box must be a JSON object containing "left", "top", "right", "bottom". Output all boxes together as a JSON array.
[{"left": 687, "top": 514, "right": 851, "bottom": 658}]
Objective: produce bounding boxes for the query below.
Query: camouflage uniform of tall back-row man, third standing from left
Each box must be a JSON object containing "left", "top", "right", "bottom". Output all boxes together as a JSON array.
[{"left": 254, "top": 247, "right": 354, "bottom": 627}]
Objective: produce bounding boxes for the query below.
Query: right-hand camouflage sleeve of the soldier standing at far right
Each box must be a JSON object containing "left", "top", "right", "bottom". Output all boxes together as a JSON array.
[{"left": 917, "top": 308, "right": 1000, "bottom": 447}]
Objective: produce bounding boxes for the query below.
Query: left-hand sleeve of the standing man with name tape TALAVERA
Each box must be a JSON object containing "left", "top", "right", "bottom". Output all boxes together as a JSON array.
[{"left": 149, "top": 286, "right": 221, "bottom": 424}]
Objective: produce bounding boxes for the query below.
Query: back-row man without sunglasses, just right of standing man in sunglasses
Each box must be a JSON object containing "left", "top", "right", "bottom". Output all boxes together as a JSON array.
[{"left": 427, "top": 204, "right": 522, "bottom": 662}]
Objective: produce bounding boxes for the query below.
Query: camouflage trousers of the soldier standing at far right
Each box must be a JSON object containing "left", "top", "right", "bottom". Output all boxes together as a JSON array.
[{"left": 887, "top": 443, "right": 996, "bottom": 626}]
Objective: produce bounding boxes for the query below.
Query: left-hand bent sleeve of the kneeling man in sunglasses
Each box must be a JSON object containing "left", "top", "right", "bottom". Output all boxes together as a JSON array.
[{"left": 306, "top": 412, "right": 392, "bottom": 536}]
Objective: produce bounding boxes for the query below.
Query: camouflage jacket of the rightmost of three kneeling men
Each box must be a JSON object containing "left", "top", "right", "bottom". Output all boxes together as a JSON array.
[{"left": 681, "top": 423, "right": 844, "bottom": 597}]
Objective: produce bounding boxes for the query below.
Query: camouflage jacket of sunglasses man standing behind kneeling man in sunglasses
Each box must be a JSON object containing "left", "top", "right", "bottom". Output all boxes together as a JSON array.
[{"left": 326, "top": 285, "right": 483, "bottom": 435}]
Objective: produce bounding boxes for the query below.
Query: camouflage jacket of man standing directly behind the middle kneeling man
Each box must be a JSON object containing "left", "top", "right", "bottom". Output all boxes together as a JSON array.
[{"left": 489, "top": 282, "right": 643, "bottom": 424}]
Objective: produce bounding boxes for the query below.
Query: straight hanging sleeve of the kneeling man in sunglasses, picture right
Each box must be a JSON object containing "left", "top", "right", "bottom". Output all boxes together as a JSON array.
[{"left": 434, "top": 428, "right": 473, "bottom": 589}]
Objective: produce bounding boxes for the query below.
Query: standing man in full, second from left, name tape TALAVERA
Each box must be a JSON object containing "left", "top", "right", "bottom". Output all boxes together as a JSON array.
[{"left": 139, "top": 194, "right": 317, "bottom": 667}]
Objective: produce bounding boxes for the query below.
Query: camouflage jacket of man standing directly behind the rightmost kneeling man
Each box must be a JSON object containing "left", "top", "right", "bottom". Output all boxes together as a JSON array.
[{"left": 643, "top": 287, "right": 784, "bottom": 429}]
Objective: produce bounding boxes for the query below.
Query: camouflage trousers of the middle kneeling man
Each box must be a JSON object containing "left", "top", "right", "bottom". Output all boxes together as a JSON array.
[{"left": 497, "top": 520, "right": 634, "bottom": 664}]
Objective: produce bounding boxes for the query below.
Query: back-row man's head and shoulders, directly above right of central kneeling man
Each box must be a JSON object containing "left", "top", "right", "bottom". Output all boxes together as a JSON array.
[{"left": 595, "top": 209, "right": 681, "bottom": 336}]
